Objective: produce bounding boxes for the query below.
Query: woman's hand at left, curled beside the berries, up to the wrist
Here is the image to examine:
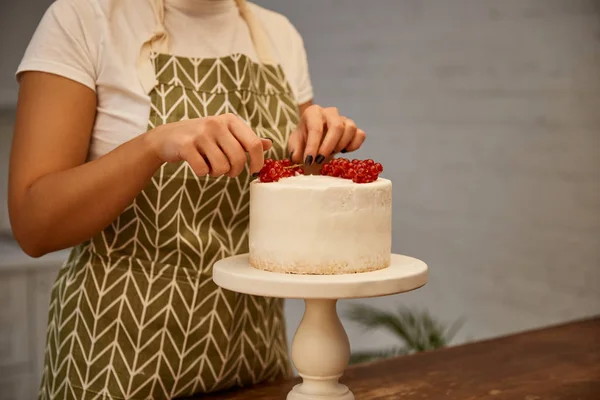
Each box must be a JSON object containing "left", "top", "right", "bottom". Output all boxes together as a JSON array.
[{"left": 146, "top": 114, "right": 273, "bottom": 178}]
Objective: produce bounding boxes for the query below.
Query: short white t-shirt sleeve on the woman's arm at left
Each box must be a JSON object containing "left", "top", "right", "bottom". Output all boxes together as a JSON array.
[{"left": 16, "top": 0, "right": 99, "bottom": 90}]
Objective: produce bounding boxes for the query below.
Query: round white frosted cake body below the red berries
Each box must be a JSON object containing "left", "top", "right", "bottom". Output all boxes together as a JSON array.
[{"left": 249, "top": 175, "right": 392, "bottom": 274}]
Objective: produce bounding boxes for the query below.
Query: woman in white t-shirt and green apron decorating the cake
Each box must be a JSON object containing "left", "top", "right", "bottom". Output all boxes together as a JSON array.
[{"left": 9, "top": 0, "right": 365, "bottom": 400}]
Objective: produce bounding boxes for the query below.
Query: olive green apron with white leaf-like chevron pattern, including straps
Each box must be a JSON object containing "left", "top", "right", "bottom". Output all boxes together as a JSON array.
[{"left": 40, "top": 0, "right": 298, "bottom": 400}]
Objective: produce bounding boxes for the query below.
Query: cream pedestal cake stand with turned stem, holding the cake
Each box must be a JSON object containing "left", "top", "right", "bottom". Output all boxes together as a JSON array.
[{"left": 213, "top": 254, "right": 427, "bottom": 400}]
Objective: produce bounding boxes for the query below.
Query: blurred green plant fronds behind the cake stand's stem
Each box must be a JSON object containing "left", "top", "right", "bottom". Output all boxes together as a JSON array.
[{"left": 346, "top": 304, "right": 462, "bottom": 364}]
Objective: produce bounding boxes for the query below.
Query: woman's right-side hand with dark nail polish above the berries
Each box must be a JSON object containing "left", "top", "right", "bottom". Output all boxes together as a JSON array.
[{"left": 288, "top": 105, "right": 366, "bottom": 166}]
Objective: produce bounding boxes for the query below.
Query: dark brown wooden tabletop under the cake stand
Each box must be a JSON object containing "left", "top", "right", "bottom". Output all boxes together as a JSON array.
[{"left": 203, "top": 317, "right": 600, "bottom": 400}]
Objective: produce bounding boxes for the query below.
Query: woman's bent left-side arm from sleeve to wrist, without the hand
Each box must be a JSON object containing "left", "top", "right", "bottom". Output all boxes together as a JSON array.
[{"left": 8, "top": 72, "right": 161, "bottom": 257}]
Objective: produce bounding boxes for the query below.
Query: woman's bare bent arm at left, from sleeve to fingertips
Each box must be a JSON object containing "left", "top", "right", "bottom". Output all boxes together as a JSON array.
[{"left": 8, "top": 72, "right": 272, "bottom": 257}]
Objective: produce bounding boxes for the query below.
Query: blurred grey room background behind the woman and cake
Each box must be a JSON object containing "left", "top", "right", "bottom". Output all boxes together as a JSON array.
[{"left": 0, "top": 0, "right": 600, "bottom": 400}]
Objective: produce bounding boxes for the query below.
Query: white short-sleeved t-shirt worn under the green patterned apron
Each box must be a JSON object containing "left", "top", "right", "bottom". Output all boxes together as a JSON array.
[{"left": 17, "top": 0, "right": 313, "bottom": 159}]
